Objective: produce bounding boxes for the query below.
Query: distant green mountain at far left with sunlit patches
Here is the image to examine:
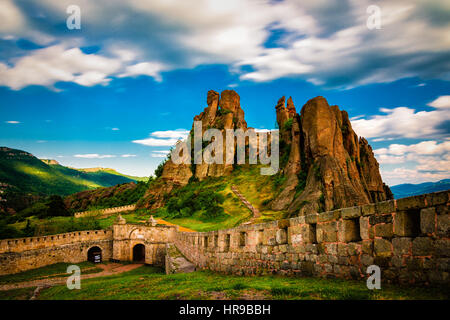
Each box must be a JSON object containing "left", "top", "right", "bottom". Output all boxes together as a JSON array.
[{"left": 0, "top": 147, "right": 136, "bottom": 211}]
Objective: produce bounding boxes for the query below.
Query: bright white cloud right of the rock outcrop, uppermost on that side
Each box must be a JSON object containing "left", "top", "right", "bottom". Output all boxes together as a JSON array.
[{"left": 352, "top": 96, "right": 450, "bottom": 141}]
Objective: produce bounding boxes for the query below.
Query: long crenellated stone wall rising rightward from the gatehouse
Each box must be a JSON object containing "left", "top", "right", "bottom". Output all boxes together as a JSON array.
[{"left": 175, "top": 191, "right": 450, "bottom": 284}]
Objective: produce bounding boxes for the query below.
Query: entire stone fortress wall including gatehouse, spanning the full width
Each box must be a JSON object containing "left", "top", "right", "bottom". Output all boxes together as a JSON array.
[{"left": 0, "top": 190, "right": 450, "bottom": 285}]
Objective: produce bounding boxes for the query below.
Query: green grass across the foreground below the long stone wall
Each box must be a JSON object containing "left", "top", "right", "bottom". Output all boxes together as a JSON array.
[{"left": 0, "top": 266, "right": 449, "bottom": 300}]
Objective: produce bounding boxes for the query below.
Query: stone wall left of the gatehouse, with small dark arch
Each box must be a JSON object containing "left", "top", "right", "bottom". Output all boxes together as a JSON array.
[{"left": 0, "top": 230, "right": 113, "bottom": 275}]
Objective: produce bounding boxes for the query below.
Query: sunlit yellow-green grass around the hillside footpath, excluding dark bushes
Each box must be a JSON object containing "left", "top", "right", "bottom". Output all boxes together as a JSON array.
[{"left": 156, "top": 165, "right": 283, "bottom": 231}]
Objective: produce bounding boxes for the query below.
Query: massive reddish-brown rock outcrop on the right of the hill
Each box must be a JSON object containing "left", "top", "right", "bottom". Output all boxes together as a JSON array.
[{"left": 272, "top": 97, "right": 392, "bottom": 215}]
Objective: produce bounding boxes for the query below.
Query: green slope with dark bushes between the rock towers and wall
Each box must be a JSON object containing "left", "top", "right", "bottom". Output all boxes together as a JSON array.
[{"left": 150, "top": 165, "right": 283, "bottom": 231}]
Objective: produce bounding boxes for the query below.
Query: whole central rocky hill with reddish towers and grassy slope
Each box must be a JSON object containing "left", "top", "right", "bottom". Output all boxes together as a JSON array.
[{"left": 137, "top": 90, "right": 393, "bottom": 226}]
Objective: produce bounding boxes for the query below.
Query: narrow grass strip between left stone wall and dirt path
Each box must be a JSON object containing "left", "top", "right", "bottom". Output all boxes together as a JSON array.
[{"left": 0, "top": 262, "right": 102, "bottom": 285}]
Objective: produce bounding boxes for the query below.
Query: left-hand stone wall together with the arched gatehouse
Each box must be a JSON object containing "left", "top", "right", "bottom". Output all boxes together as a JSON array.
[{"left": 0, "top": 224, "right": 177, "bottom": 275}]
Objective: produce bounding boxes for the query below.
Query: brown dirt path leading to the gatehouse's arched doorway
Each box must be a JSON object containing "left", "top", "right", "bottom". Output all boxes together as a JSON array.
[{"left": 0, "top": 263, "right": 143, "bottom": 291}]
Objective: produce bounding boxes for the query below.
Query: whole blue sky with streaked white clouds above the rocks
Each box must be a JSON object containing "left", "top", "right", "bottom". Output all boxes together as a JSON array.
[{"left": 0, "top": 0, "right": 450, "bottom": 185}]
